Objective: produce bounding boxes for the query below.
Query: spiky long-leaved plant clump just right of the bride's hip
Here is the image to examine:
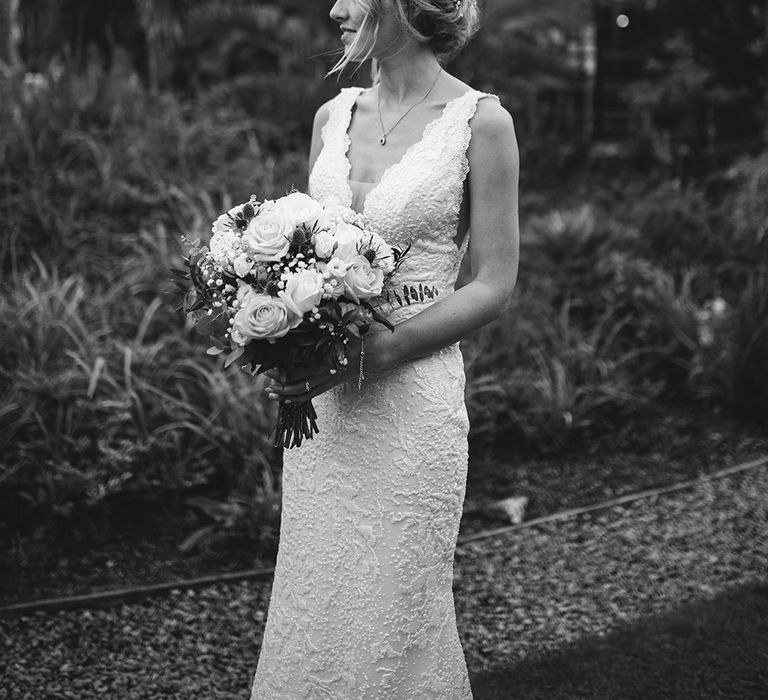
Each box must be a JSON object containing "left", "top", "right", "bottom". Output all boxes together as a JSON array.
[{"left": 465, "top": 296, "right": 663, "bottom": 452}]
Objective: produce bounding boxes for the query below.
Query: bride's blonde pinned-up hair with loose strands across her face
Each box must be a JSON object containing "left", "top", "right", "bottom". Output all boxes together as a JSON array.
[{"left": 328, "top": 0, "right": 480, "bottom": 75}]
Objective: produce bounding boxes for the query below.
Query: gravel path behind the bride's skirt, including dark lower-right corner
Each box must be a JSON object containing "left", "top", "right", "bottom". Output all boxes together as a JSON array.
[{"left": 0, "top": 467, "right": 768, "bottom": 700}]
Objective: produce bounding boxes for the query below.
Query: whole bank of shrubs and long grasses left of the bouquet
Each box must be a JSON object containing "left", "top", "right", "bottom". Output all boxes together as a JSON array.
[{"left": 0, "top": 58, "right": 294, "bottom": 535}]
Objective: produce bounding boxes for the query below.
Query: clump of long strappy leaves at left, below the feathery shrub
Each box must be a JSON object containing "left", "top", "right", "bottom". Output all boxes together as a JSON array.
[{"left": 0, "top": 246, "right": 273, "bottom": 540}]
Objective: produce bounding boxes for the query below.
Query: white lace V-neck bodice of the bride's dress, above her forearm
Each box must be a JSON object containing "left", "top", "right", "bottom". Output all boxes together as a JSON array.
[{"left": 309, "top": 87, "right": 495, "bottom": 320}]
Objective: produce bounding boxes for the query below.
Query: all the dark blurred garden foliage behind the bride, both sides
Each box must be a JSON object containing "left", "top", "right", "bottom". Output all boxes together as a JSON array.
[{"left": 0, "top": 0, "right": 768, "bottom": 547}]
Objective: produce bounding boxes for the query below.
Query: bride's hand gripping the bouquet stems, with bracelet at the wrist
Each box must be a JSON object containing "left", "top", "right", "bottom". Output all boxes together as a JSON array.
[{"left": 265, "top": 339, "right": 368, "bottom": 403}]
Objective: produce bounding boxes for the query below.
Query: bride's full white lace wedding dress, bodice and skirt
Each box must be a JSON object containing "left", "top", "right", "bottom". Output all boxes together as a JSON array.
[{"left": 251, "top": 88, "right": 496, "bottom": 700}]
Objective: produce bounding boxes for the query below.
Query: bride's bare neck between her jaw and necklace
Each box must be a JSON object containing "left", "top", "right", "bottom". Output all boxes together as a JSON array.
[{"left": 379, "top": 42, "right": 440, "bottom": 107}]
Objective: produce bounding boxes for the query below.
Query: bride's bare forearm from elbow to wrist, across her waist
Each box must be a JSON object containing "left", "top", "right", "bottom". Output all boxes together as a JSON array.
[{"left": 365, "top": 279, "right": 514, "bottom": 370}]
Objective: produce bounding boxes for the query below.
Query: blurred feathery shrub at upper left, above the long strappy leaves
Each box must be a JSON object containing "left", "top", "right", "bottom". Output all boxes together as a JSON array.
[{"left": 0, "top": 54, "right": 306, "bottom": 277}]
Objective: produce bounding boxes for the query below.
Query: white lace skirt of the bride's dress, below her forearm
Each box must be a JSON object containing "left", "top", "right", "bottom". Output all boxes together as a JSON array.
[{"left": 251, "top": 344, "right": 472, "bottom": 700}]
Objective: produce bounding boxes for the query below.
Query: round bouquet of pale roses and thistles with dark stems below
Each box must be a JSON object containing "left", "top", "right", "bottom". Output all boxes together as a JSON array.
[{"left": 173, "top": 192, "right": 437, "bottom": 448}]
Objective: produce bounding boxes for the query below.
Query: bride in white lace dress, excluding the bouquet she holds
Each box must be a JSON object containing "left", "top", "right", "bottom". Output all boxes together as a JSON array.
[{"left": 251, "top": 0, "right": 519, "bottom": 700}]
